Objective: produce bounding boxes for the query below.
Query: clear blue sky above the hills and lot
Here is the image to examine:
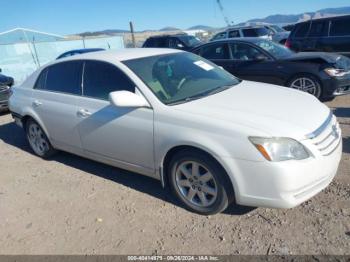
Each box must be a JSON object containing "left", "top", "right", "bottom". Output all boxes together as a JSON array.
[{"left": 0, "top": 0, "right": 350, "bottom": 35}]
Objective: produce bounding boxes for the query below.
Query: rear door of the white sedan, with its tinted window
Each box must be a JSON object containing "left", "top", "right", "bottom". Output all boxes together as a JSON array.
[{"left": 32, "top": 61, "right": 82, "bottom": 152}]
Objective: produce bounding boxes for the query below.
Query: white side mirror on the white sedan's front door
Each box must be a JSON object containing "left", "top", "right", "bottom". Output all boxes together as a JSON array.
[{"left": 109, "top": 91, "right": 150, "bottom": 107}]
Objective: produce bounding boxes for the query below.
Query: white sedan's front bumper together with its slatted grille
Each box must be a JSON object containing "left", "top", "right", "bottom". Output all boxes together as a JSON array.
[{"left": 222, "top": 114, "right": 342, "bottom": 208}]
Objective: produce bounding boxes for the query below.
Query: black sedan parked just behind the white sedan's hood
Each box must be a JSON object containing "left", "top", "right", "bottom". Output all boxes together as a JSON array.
[{"left": 192, "top": 38, "right": 350, "bottom": 99}]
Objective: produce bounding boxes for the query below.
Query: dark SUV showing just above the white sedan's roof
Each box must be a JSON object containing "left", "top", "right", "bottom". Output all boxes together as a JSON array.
[{"left": 142, "top": 34, "right": 202, "bottom": 51}]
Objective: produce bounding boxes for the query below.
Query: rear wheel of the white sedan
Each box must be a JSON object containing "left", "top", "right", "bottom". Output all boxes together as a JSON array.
[{"left": 25, "top": 118, "right": 56, "bottom": 159}]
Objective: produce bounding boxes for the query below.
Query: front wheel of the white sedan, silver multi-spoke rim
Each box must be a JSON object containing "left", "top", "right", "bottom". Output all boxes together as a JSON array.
[{"left": 167, "top": 150, "right": 233, "bottom": 215}]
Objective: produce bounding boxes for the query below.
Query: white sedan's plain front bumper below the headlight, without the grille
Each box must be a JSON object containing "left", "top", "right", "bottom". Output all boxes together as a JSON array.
[{"left": 226, "top": 138, "right": 342, "bottom": 208}]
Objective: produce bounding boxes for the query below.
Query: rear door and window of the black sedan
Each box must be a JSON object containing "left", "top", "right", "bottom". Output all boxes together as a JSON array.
[{"left": 200, "top": 42, "right": 234, "bottom": 74}]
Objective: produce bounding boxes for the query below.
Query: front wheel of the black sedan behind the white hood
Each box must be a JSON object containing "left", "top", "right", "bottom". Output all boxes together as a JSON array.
[{"left": 287, "top": 74, "right": 323, "bottom": 99}]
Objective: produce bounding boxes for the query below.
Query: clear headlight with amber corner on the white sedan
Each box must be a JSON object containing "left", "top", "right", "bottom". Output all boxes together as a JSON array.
[{"left": 249, "top": 137, "right": 310, "bottom": 162}]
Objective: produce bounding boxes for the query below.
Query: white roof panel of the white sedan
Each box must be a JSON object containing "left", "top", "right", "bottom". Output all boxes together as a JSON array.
[{"left": 55, "top": 48, "right": 183, "bottom": 61}]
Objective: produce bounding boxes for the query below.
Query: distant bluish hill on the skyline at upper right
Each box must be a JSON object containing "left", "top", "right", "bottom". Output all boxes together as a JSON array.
[{"left": 247, "top": 6, "right": 350, "bottom": 24}]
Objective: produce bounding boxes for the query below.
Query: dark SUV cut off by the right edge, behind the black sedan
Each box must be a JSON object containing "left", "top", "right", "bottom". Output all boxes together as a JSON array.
[{"left": 286, "top": 15, "right": 350, "bottom": 56}]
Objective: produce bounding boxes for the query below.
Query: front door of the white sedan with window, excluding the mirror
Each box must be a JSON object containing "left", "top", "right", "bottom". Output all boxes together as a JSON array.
[{"left": 78, "top": 61, "right": 154, "bottom": 174}]
